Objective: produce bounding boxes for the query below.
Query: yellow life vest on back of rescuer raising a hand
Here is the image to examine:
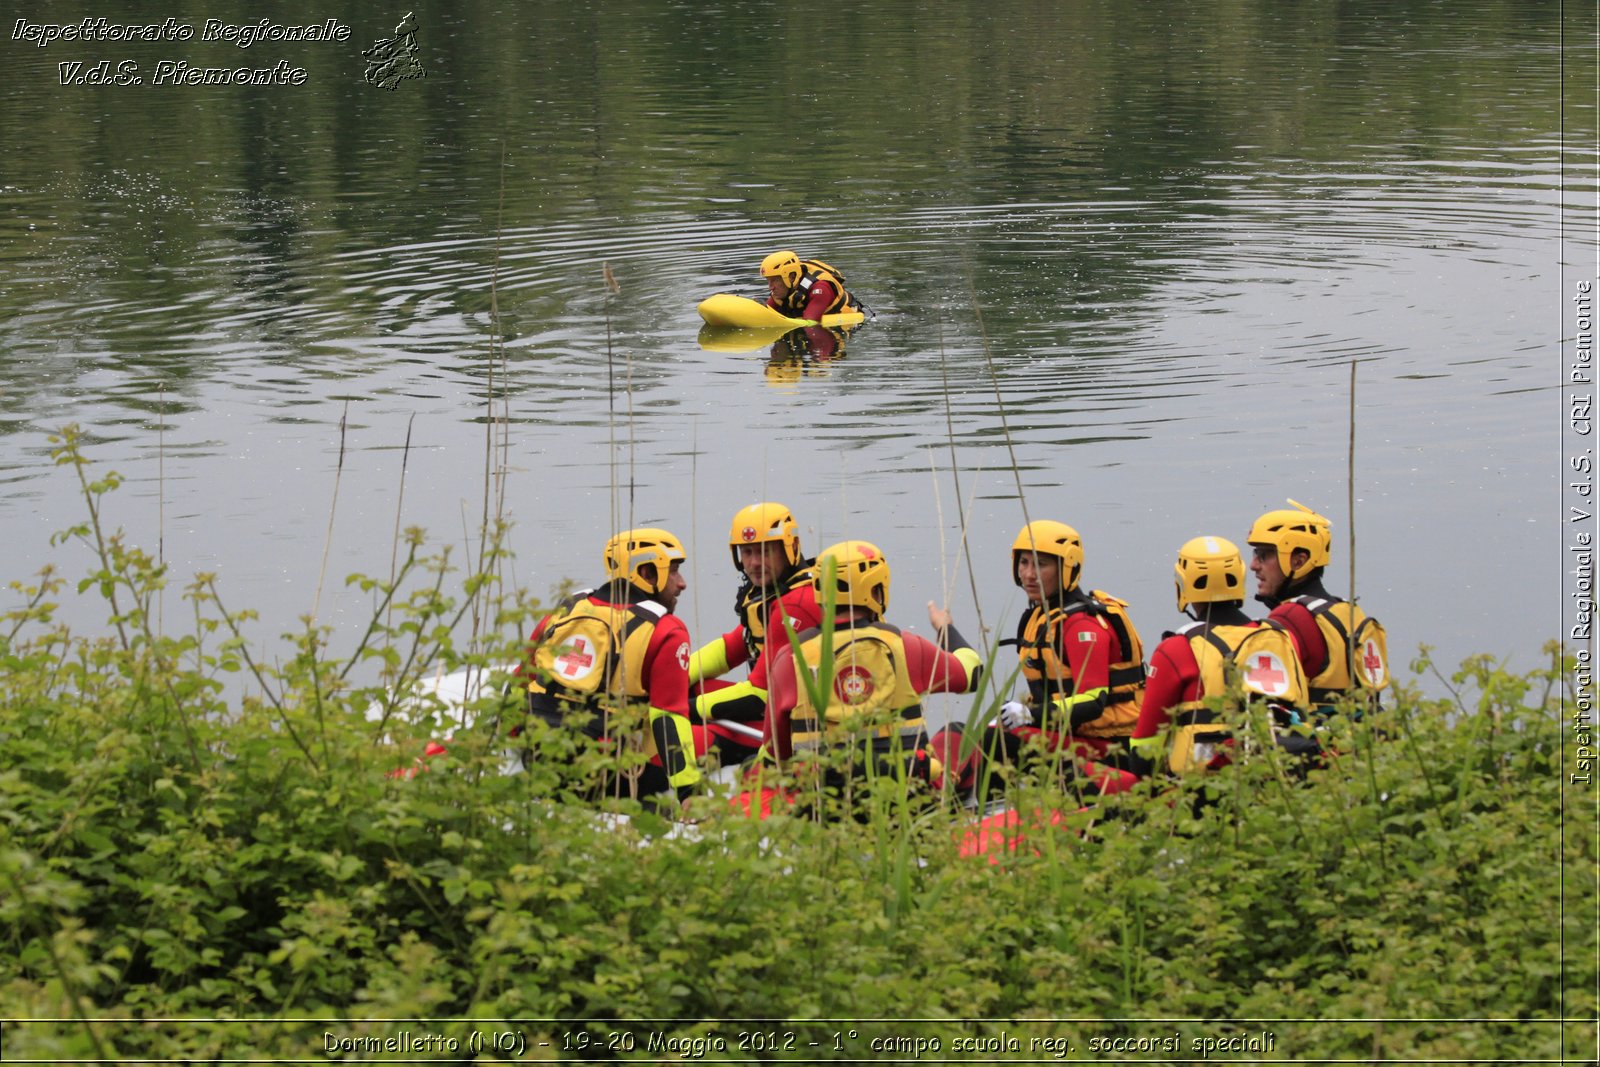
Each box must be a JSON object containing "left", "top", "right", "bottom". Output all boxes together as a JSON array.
[{"left": 790, "top": 622, "right": 923, "bottom": 749}]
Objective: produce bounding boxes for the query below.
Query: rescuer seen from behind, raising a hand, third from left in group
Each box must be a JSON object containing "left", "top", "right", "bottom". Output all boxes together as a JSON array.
[{"left": 763, "top": 541, "right": 982, "bottom": 789}]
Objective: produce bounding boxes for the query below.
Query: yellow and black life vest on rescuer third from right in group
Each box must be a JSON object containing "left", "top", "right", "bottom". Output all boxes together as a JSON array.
[{"left": 1016, "top": 589, "right": 1144, "bottom": 737}]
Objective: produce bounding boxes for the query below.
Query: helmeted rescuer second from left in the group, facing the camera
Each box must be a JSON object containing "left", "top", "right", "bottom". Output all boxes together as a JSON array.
[{"left": 690, "top": 501, "right": 822, "bottom": 765}]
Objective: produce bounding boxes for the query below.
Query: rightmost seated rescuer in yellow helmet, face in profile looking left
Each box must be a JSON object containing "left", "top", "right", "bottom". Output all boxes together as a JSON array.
[{"left": 1248, "top": 501, "right": 1389, "bottom": 713}]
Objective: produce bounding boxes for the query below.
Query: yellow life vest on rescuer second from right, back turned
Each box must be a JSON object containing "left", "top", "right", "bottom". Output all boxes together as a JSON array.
[{"left": 1166, "top": 622, "right": 1309, "bottom": 774}]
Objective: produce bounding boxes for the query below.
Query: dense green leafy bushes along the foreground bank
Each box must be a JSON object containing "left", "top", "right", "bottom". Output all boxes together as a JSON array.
[{"left": 0, "top": 434, "right": 1597, "bottom": 1062}]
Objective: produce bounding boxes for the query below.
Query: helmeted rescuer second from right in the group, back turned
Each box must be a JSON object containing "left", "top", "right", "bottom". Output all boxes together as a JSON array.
[{"left": 1126, "top": 536, "right": 1315, "bottom": 792}]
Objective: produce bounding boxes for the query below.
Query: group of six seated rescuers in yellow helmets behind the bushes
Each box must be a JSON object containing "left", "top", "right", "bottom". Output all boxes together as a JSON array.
[{"left": 522, "top": 501, "right": 1389, "bottom": 812}]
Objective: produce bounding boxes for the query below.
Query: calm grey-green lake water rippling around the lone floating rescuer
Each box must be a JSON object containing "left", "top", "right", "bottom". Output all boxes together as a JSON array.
[{"left": 0, "top": 0, "right": 1597, "bottom": 710}]
